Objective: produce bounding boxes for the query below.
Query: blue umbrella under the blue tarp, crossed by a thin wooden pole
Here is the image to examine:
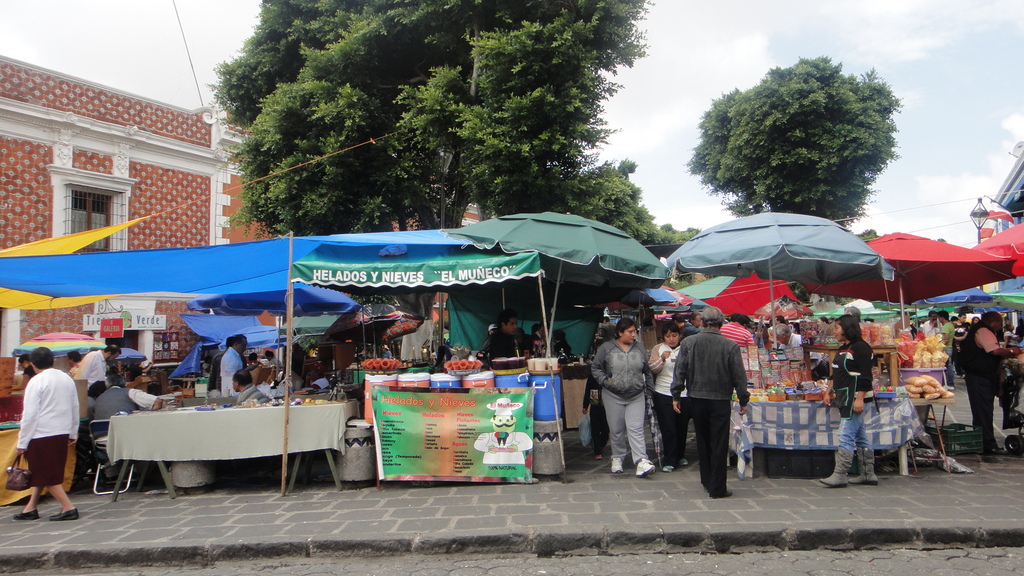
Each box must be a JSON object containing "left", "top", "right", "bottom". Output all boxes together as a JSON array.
[{"left": 188, "top": 284, "right": 361, "bottom": 316}]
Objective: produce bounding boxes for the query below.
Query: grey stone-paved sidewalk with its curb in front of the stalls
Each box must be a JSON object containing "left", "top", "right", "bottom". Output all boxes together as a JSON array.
[{"left": 0, "top": 388, "right": 1024, "bottom": 572}]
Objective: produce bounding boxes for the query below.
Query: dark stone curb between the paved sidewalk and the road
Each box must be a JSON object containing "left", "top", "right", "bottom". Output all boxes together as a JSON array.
[{"left": 0, "top": 524, "right": 1024, "bottom": 574}]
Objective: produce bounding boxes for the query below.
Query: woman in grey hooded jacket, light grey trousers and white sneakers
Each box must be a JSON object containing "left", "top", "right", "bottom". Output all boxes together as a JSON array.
[{"left": 590, "top": 318, "right": 654, "bottom": 477}]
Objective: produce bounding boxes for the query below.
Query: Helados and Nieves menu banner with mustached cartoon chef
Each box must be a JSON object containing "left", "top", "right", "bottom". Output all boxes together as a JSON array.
[{"left": 373, "top": 386, "right": 534, "bottom": 483}]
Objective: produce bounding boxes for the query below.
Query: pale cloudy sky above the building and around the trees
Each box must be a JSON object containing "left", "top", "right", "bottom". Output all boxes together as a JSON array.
[{"left": 0, "top": 0, "right": 1024, "bottom": 246}]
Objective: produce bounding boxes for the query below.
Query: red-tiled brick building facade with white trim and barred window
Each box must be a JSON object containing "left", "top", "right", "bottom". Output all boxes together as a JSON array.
[{"left": 0, "top": 56, "right": 241, "bottom": 362}]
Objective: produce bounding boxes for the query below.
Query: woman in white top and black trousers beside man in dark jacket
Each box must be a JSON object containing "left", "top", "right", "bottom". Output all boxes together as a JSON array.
[{"left": 647, "top": 322, "right": 690, "bottom": 472}]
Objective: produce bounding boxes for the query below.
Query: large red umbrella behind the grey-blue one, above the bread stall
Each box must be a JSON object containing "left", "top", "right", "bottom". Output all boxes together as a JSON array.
[{"left": 805, "top": 233, "right": 1015, "bottom": 303}]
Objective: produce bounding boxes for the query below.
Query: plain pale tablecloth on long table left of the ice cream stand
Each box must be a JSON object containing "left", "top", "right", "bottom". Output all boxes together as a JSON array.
[{"left": 108, "top": 402, "right": 358, "bottom": 461}]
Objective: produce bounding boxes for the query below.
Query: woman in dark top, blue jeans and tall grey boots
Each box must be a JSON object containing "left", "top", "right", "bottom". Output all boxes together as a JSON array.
[{"left": 820, "top": 315, "right": 879, "bottom": 488}]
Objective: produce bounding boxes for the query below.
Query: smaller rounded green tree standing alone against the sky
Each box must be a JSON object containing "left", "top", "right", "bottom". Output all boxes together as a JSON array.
[{"left": 689, "top": 57, "right": 900, "bottom": 219}]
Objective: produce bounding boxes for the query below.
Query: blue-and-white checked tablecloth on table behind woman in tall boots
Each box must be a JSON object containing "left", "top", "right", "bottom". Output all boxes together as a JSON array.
[{"left": 732, "top": 398, "right": 924, "bottom": 476}]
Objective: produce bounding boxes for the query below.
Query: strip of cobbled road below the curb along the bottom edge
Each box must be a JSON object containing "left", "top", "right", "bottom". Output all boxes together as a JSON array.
[{"left": 19, "top": 548, "right": 1024, "bottom": 576}]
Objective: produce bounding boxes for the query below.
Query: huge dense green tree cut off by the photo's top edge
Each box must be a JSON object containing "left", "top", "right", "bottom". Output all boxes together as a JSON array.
[{"left": 217, "top": 0, "right": 660, "bottom": 241}]
